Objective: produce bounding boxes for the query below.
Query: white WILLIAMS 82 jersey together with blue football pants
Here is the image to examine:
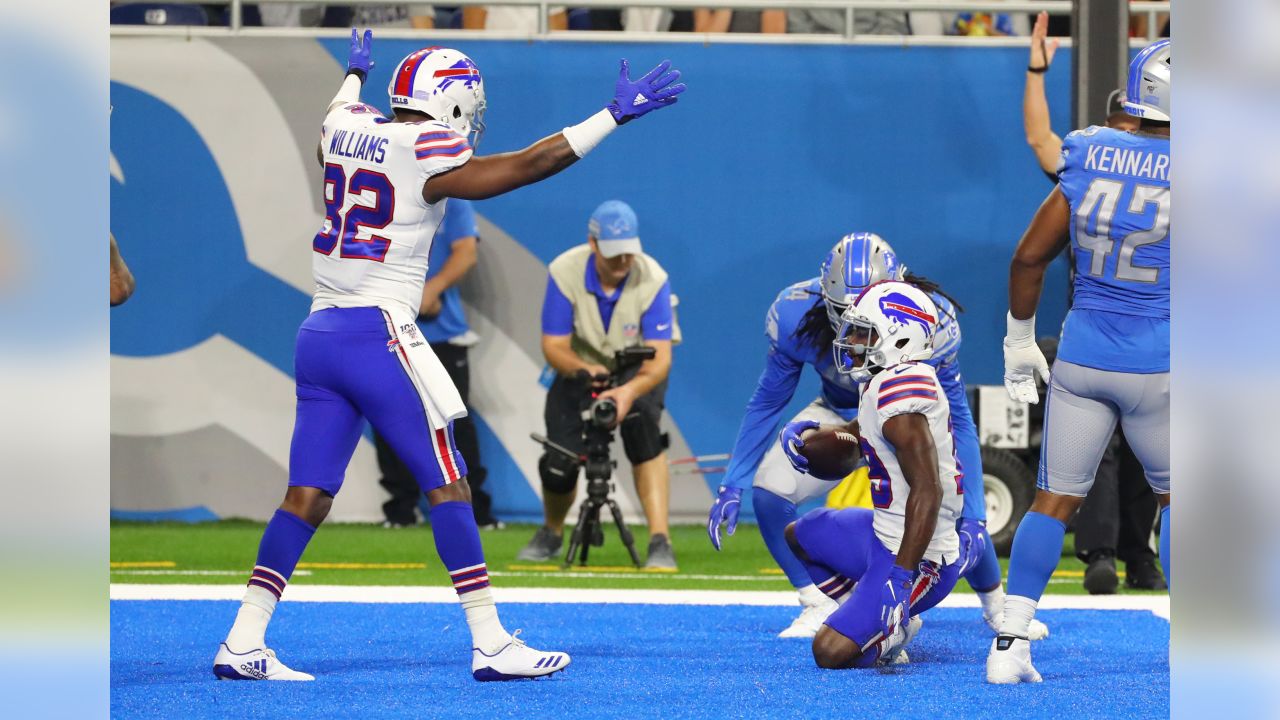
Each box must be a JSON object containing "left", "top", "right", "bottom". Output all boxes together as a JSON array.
[{"left": 289, "top": 102, "right": 472, "bottom": 495}]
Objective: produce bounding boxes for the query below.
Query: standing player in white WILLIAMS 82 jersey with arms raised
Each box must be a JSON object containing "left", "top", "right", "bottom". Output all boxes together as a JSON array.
[{"left": 214, "top": 29, "right": 685, "bottom": 680}]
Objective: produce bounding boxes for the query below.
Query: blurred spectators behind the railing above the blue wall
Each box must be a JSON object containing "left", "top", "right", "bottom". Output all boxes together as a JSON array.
[{"left": 111, "top": 1, "right": 1169, "bottom": 37}]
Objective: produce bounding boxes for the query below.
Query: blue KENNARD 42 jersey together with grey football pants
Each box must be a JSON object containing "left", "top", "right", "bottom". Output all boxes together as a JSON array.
[{"left": 1038, "top": 127, "right": 1170, "bottom": 497}]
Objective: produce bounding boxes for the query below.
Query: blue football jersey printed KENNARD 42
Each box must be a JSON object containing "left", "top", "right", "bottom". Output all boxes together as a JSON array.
[{"left": 1057, "top": 127, "right": 1170, "bottom": 373}]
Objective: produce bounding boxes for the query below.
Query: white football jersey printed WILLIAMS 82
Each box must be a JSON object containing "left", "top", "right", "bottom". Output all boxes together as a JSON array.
[{"left": 311, "top": 102, "right": 471, "bottom": 316}]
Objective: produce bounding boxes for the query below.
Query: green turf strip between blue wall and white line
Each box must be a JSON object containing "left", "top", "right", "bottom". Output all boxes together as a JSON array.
[{"left": 111, "top": 520, "right": 1172, "bottom": 594}]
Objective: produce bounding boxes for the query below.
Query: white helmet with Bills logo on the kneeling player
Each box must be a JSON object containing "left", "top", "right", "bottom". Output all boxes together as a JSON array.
[{"left": 832, "top": 281, "right": 938, "bottom": 383}]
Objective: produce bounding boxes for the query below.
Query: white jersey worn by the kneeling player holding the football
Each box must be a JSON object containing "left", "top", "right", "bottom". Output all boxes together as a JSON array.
[{"left": 858, "top": 363, "right": 964, "bottom": 564}]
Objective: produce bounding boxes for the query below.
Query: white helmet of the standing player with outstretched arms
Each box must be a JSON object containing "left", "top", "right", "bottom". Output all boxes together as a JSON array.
[{"left": 387, "top": 47, "right": 485, "bottom": 147}]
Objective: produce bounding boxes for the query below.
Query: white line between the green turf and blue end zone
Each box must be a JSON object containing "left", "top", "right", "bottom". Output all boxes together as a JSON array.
[{"left": 111, "top": 583, "right": 1169, "bottom": 619}]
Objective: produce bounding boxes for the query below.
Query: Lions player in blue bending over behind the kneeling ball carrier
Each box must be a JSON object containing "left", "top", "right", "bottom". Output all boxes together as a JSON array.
[{"left": 707, "top": 232, "right": 1048, "bottom": 638}]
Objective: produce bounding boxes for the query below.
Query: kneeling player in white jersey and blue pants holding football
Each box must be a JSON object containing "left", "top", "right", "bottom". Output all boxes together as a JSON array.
[{"left": 786, "top": 281, "right": 967, "bottom": 669}]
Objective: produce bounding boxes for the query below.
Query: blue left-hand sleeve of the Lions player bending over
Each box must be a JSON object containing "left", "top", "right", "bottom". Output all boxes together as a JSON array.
[{"left": 722, "top": 346, "right": 804, "bottom": 488}]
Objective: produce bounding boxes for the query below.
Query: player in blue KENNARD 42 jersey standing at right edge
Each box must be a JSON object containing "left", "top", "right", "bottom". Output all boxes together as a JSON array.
[{"left": 987, "top": 40, "right": 1172, "bottom": 684}]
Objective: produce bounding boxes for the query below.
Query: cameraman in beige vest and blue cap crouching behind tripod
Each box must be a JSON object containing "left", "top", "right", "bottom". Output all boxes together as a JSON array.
[{"left": 517, "top": 200, "right": 678, "bottom": 569}]
